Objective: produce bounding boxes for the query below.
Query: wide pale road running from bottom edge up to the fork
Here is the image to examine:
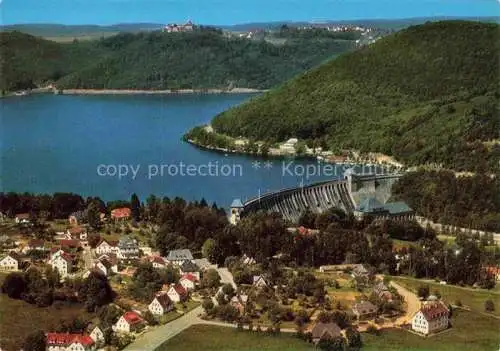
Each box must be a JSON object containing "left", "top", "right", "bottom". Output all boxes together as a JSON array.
[{"left": 125, "top": 306, "right": 203, "bottom": 351}]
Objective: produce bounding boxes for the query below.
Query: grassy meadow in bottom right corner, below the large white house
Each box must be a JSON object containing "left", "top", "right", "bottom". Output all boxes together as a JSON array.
[{"left": 363, "top": 310, "right": 500, "bottom": 351}]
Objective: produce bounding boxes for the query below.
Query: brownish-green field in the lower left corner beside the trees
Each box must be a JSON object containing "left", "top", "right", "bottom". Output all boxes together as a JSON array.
[{"left": 0, "top": 274, "right": 92, "bottom": 351}]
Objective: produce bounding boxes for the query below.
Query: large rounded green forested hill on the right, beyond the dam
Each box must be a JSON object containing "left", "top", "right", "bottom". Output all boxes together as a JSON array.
[{"left": 213, "top": 21, "right": 500, "bottom": 171}]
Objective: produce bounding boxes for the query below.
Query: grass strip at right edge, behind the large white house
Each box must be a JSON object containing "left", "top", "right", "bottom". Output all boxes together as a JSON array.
[{"left": 392, "top": 277, "right": 500, "bottom": 316}]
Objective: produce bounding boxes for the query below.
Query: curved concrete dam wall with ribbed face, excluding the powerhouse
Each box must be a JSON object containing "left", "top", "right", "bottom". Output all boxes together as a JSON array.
[{"left": 241, "top": 172, "right": 401, "bottom": 222}]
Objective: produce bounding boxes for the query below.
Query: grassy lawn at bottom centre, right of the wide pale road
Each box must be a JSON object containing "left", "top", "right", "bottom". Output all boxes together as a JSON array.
[{"left": 156, "top": 325, "right": 314, "bottom": 351}]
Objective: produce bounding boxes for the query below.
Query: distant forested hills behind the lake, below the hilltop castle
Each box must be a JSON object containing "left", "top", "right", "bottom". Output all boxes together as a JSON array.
[{"left": 0, "top": 28, "right": 355, "bottom": 90}]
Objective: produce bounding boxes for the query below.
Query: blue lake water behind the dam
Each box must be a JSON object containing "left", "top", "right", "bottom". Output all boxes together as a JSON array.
[{"left": 0, "top": 94, "right": 352, "bottom": 207}]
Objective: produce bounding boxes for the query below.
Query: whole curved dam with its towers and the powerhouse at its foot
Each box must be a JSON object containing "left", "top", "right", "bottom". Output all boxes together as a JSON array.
[{"left": 230, "top": 170, "right": 414, "bottom": 224}]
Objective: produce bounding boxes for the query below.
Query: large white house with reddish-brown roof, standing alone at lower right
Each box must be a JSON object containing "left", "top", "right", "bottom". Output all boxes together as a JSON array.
[{"left": 411, "top": 301, "right": 449, "bottom": 335}]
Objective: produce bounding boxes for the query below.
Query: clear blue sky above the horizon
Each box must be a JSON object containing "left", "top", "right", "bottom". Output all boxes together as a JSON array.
[{"left": 0, "top": 0, "right": 500, "bottom": 25}]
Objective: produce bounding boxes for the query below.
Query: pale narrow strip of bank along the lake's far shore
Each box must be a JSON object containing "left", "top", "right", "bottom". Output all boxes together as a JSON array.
[{"left": 58, "top": 88, "right": 267, "bottom": 95}]
